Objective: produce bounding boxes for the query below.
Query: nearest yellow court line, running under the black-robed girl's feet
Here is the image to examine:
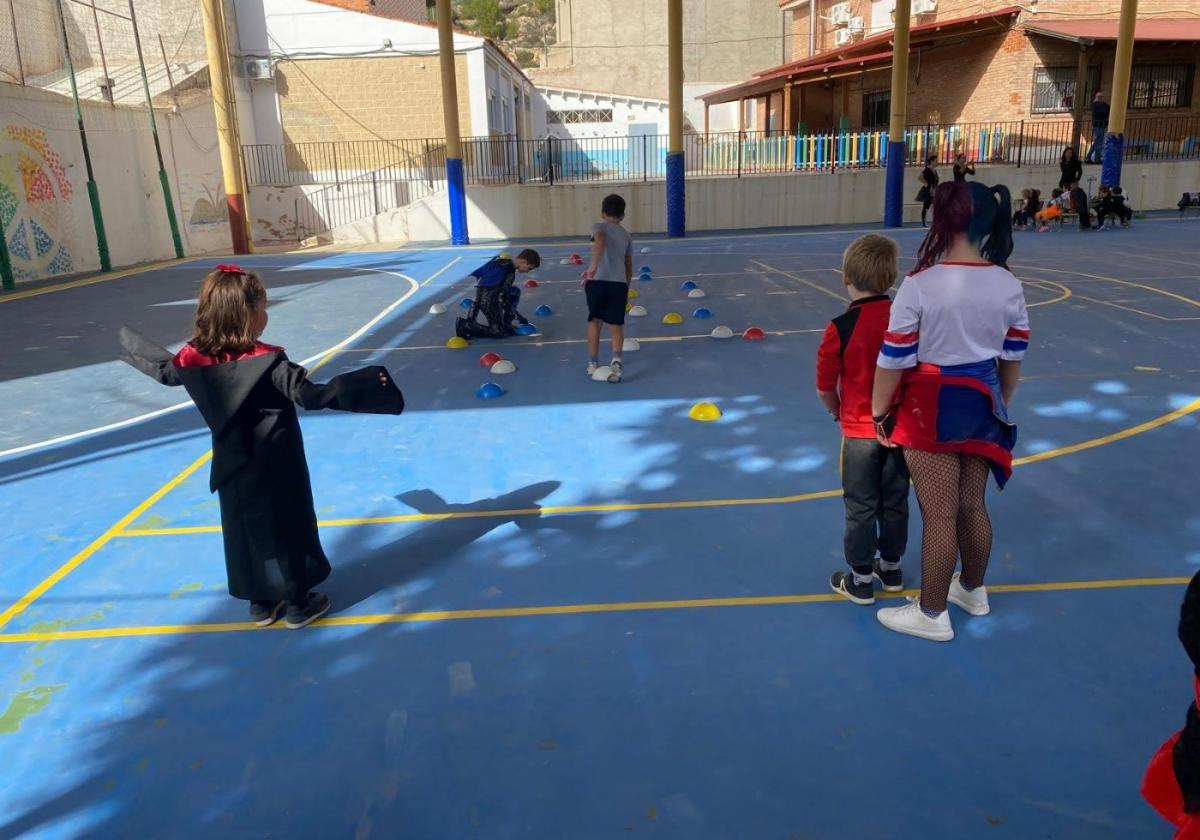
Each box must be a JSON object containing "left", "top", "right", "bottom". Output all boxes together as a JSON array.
[{"left": 0, "top": 577, "right": 1190, "bottom": 644}]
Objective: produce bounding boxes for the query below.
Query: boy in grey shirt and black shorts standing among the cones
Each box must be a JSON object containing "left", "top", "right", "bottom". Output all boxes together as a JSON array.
[{"left": 580, "top": 194, "right": 634, "bottom": 384}]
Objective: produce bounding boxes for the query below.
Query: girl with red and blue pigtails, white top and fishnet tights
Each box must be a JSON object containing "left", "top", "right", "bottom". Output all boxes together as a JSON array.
[{"left": 871, "top": 182, "right": 1030, "bottom": 642}]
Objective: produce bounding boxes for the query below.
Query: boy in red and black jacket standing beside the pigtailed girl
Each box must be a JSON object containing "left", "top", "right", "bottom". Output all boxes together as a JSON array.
[{"left": 817, "top": 234, "right": 908, "bottom": 604}]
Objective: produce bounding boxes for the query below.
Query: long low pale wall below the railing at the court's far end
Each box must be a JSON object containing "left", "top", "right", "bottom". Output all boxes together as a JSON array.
[{"left": 335, "top": 161, "right": 1200, "bottom": 242}]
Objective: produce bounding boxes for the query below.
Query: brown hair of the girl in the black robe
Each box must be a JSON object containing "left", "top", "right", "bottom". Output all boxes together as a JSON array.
[{"left": 190, "top": 266, "right": 266, "bottom": 359}]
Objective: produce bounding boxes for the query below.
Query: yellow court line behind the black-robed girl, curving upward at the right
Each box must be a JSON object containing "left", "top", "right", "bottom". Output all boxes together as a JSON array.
[{"left": 118, "top": 400, "right": 1200, "bottom": 538}]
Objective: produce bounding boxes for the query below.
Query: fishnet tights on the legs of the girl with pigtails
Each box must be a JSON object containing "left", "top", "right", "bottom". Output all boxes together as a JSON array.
[{"left": 904, "top": 449, "right": 991, "bottom": 612}]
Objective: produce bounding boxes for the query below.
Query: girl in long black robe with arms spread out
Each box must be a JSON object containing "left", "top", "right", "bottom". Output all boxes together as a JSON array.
[{"left": 121, "top": 265, "right": 404, "bottom": 628}]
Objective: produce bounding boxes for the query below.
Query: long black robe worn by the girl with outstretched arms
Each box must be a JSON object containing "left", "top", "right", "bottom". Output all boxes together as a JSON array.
[{"left": 121, "top": 328, "right": 404, "bottom": 602}]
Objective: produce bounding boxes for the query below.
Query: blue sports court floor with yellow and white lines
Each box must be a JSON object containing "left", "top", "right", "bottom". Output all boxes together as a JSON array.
[{"left": 0, "top": 216, "right": 1200, "bottom": 840}]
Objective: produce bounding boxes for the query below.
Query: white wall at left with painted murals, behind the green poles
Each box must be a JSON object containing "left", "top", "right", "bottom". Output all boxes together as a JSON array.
[{"left": 0, "top": 84, "right": 229, "bottom": 281}]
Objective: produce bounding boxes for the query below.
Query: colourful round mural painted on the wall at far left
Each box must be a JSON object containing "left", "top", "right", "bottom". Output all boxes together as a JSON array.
[{"left": 0, "top": 125, "right": 76, "bottom": 281}]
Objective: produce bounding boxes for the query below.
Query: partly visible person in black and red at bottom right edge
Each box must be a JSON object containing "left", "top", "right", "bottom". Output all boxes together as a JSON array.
[{"left": 1141, "top": 572, "right": 1200, "bottom": 840}]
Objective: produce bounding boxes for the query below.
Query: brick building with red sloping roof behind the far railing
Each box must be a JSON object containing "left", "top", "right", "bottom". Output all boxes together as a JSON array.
[{"left": 703, "top": 0, "right": 1200, "bottom": 144}]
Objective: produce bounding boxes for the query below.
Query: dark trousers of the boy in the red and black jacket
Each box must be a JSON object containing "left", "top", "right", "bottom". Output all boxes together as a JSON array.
[{"left": 841, "top": 438, "right": 908, "bottom": 574}]
